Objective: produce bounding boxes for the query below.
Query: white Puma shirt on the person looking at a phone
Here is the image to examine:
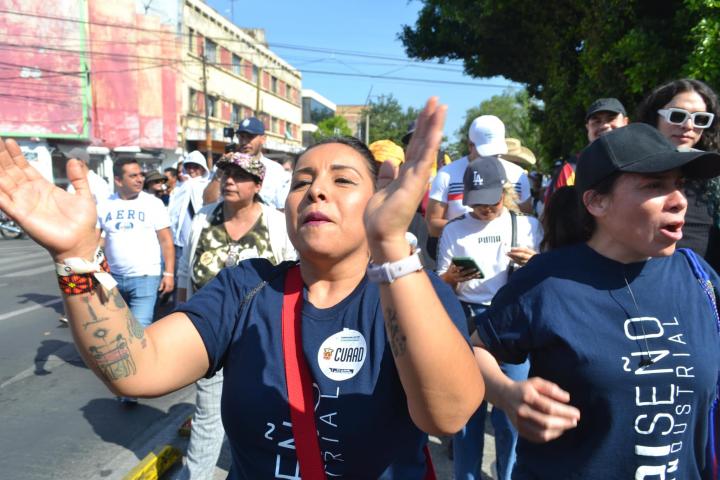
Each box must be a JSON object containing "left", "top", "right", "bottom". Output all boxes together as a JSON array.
[{"left": 437, "top": 208, "right": 543, "bottom": 305}]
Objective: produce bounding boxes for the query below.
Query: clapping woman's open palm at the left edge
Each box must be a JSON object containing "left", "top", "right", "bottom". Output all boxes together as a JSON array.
[{"left": 0, "top": 139, "right": 99, "bottom": 260}]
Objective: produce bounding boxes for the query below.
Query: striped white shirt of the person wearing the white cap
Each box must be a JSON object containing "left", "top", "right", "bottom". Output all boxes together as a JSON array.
[{"left": 430, "top": 157, "right": 530, "bottom": 220}]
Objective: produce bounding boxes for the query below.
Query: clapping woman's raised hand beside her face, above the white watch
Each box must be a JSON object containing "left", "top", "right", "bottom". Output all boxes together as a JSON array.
[{"left": 365, "top": 97, "right": 447, "bottom": 262}]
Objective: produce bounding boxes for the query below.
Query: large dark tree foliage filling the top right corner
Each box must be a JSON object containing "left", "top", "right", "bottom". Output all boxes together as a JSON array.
[{"left": 400, "top": 0, "right": 720, "bottom": 161}]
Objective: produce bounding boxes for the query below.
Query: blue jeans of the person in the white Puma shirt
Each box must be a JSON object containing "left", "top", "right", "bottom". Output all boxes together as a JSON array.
[{"left": 453, "top": 302, "right": 530, "bottom": 480}]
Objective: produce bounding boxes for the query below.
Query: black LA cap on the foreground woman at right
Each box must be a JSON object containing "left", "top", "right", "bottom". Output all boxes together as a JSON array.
[{"left": 575, "top": 123, "right": 720, "bottom": 196}]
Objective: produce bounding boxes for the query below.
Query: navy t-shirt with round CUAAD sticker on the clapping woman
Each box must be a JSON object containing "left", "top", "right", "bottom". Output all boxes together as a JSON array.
[{"left": 178, "top": 259, "right": 469, "bottom": 480}]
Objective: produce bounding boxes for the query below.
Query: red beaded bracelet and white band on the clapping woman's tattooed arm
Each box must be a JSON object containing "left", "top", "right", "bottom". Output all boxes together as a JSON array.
[{"left": 55, "top": 248, "right": 117, "bottom": 295}]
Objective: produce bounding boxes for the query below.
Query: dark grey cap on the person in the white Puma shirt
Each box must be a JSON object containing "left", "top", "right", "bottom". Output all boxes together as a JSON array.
[{"left": 463, "top": 157, "right": 505, "bottom": 207}]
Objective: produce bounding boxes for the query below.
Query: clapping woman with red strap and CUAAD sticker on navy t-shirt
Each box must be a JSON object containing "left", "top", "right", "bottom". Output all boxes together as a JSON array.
[{"left": 0, "top": 99, "right": 484, "bottom": 480}]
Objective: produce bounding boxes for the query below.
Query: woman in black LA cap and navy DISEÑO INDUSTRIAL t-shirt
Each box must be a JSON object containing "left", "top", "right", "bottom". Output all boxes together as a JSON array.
[{"left": 475, "top": 124, "right": 720, "bottom": 479}]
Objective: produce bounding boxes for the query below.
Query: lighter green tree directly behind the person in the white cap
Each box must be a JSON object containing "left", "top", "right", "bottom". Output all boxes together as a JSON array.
[{"left": 448, "top": 90, "right": 547, "bottom": 168}]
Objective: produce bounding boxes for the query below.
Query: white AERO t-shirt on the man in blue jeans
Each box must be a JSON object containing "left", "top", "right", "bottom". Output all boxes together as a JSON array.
[{"left": 97, "top": 192, "right": 170, "bottom": 277}]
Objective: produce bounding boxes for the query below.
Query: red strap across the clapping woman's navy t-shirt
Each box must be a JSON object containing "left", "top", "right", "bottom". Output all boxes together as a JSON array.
[{"left": 282, "top": 266, "right": 325, "bottom": 480}]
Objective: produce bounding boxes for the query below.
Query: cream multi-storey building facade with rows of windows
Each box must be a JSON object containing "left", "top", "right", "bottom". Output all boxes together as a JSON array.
[{"left": 183, "top": 0, "right": 302, "bottom": 165}]
